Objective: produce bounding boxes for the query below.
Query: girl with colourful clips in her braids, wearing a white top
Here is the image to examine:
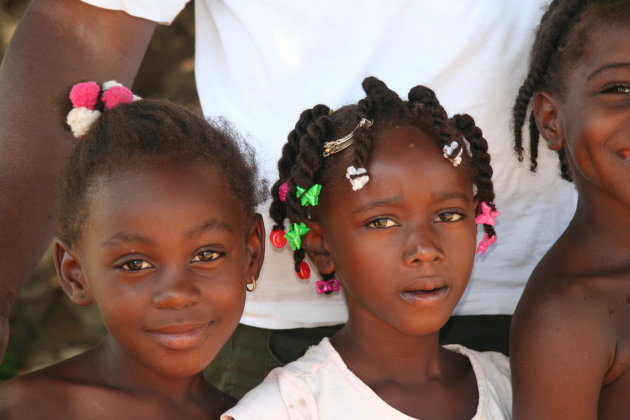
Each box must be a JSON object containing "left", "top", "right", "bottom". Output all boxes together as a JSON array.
[{"left": 224, "top": 77, "right": 511, "bottom": 420}]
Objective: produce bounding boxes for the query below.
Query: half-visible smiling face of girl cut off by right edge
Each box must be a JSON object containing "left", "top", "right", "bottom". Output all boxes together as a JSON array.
[{"left": 543, "top": 14, "right": 630, "bottom": 206}]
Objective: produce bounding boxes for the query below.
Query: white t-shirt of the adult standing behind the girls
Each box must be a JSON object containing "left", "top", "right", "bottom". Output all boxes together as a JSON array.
[{"left": 84, "top": 0, "right": 576, "bottom": 329}]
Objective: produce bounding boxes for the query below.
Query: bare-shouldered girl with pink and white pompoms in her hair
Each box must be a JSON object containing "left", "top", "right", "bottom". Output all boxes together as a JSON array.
[{"left": 0, "top": 82, "right": 264, "bottom": 419}]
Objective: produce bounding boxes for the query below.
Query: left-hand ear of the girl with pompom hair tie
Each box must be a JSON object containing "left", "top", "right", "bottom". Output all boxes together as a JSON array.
[{"left": 53, "top": 240, "right": 94, "bottom": 306}]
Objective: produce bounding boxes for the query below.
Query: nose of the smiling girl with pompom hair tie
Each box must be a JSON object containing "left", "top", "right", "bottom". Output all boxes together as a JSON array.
[{"left": 152, "top": 269, "right": 201, "bottom": 310}]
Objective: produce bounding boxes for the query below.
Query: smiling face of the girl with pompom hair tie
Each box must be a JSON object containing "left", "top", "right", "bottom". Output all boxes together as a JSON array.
[{"left": 57, "top": 159, "right": 264, "bottom": 378}]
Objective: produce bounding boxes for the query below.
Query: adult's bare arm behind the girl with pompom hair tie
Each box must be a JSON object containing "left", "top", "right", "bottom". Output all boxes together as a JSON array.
[{"left": 0, "top": 0, "right": 155, "bottom": 360}]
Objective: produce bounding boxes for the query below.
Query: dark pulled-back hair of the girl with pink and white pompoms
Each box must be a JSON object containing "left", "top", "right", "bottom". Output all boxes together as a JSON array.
[{"left": 57, "top": 90, "right": 268, "bottom": 246}]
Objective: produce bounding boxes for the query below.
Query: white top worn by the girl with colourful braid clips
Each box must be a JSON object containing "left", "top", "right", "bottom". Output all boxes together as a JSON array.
[{"left": 221, "top": 338, "right": 512, "bottom": 420}]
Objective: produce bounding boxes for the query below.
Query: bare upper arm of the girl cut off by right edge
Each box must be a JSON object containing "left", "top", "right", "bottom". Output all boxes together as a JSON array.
[{"left": 510, "top": 284, "right": 614, "bottom": 420}]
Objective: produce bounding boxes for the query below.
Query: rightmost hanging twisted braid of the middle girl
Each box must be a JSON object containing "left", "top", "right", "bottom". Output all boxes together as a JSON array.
[{"left": 450, "top": 114, "right": 496, "bottom": 240}]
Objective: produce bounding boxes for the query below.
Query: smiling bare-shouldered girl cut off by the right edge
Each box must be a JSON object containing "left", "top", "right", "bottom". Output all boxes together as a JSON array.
[{"left": 510, "top": 0, "right": 630, "bottom": 419}]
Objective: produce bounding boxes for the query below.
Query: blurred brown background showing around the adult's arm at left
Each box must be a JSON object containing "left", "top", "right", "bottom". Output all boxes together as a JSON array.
[{"left": 0, "top": 0, "right": 199, "bottom": 379}]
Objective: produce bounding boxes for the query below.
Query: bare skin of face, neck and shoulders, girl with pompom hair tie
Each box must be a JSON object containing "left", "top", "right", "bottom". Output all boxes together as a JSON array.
[{"left": 0, "top": 162, "right": 265, "bottom": 419}]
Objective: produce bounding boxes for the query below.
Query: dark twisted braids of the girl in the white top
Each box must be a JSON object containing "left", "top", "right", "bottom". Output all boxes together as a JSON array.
[{"left": 270, "top": 77, "right": 496, "bottom": 272}]
